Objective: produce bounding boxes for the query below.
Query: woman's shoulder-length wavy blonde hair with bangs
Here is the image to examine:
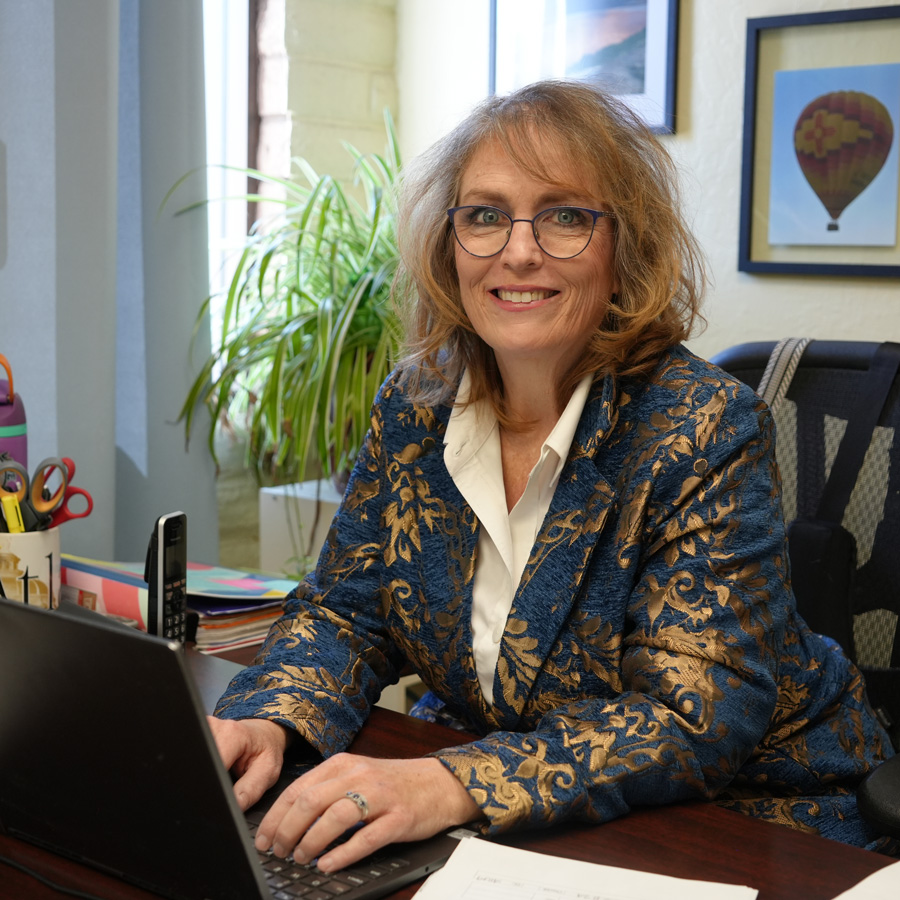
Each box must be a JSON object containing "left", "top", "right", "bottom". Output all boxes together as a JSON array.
[{"left": 395, "top": 81, "right": 705, "bottom": 426}]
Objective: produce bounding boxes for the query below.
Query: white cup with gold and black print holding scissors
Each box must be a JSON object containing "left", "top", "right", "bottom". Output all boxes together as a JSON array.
[{"left": 0, "top": 528, "right": 60, "bottom": 609}]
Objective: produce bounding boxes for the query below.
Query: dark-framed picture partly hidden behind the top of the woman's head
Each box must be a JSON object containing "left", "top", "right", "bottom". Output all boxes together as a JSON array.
[{"left": 490, "top": 0, "right": 679, "bottom": 134}]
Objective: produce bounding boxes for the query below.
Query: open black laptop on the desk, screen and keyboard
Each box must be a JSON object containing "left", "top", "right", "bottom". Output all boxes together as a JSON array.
[{"left": 0, "top": 597, "right": 470, "bottom": 900}]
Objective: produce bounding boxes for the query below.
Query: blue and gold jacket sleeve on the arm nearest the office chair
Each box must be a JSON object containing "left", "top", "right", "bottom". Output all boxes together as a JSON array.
[{"left": 434, "top": 392, "right": 793, "bottom": 833}]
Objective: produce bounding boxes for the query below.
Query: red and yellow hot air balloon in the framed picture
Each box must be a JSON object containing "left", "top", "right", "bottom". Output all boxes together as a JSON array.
[{"left": 794, "top": 91, "right": 894, "bottom": 231}]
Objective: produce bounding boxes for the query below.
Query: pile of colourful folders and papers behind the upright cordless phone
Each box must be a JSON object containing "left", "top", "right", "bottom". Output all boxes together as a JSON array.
[{"left": 61, "top": 553, "right": 296, "bottom": 653}]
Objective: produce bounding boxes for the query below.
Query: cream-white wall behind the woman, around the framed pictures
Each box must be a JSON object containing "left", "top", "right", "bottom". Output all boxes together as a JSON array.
[{"left": 397, "top": 0, "right": 900, "bottom": 356}]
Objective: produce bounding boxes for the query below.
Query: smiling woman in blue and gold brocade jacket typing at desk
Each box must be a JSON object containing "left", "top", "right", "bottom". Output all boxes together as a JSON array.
[{"left": 212, "top": 82, "right": 890, "bottom": 871}]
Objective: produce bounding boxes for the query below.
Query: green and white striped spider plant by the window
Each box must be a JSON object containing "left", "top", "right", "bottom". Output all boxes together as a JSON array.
[{"left": 180, "top": 113, "right": 400, "bottom": 486}]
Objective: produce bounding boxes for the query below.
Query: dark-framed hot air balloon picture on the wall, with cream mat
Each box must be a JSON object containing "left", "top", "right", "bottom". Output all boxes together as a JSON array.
[{"left": 738, "top": 6, "right": 900, "bottom": 278}]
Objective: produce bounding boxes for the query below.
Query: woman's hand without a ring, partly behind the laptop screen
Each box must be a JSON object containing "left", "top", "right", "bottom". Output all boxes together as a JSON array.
[{"left": 207, "top": 716, "right": 291, "bottom": 810}]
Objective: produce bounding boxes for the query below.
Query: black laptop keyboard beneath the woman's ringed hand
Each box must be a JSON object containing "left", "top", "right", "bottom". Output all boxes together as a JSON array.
[{"left": 247, "top": 815, "right": 409, "bottom": 900}]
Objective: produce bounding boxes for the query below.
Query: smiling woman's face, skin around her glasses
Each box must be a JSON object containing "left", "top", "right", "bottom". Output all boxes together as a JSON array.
[{"left": 455, "top": 142, "right": 618, "bottom": 376}]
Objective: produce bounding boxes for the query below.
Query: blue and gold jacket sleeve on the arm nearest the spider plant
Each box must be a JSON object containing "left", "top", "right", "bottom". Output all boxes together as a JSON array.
[{"left": 215, "top": 379, "right": 402, "bottom": 756}]
